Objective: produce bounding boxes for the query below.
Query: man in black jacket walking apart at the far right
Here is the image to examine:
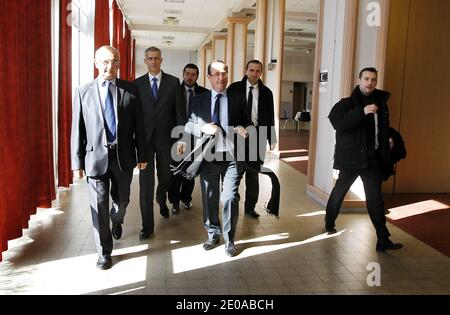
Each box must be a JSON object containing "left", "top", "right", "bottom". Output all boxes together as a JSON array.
[{"left": 325, "top": 68, "right": 403, "bottom": 251}]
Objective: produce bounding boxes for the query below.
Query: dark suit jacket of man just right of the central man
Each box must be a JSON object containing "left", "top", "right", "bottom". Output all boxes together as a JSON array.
[{"left": 228, "top": 76, "right": 277, "bottom": 145}]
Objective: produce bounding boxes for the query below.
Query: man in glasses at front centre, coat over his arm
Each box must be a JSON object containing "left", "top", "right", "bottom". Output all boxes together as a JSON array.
[{"left": 185, "top": 60, "right": 251, "bottom": 256}]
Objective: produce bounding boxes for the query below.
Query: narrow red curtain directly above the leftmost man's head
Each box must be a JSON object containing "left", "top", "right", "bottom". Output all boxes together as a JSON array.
[{"left": 94, "top": 0, "right": 111, "bottom": 77}]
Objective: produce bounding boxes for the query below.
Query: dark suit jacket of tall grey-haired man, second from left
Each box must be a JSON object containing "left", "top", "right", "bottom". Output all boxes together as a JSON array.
[{"left": 134, "top": 71, "right": 186, "bottom": 143}]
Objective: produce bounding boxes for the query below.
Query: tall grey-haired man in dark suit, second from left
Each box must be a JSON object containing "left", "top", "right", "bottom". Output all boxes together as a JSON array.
[{"left": 135, "top": 47, "right": 186, "bottom": 239}]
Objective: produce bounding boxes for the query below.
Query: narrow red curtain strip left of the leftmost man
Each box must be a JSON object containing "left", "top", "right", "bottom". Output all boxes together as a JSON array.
[{"left": 58, "top": 0, "right": 72, "bottom": 187}]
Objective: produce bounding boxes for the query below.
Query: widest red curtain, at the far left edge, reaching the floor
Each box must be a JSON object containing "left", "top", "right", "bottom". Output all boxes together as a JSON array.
[{"left": 0, "top": 0, "right": 55, "bottom": 258}]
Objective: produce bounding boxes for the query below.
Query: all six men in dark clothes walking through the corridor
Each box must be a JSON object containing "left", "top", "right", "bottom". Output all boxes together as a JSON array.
[{"left": 71, "top": 46, "right": 401, "bottom": 269}]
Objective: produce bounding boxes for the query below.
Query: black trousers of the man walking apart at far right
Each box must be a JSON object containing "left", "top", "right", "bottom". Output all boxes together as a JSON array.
[{"left": 325, "top": 164, "right": 390, "bottom": 240}]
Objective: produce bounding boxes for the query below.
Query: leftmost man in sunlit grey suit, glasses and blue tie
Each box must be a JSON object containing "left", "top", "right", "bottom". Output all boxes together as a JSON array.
[{"left": 71, "top": 46, "right": 147, "bottom": 269}]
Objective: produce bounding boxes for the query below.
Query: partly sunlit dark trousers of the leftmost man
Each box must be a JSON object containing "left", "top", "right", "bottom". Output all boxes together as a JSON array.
[{"left": 87, "top": 149, "right": 133, "bottom": 256}]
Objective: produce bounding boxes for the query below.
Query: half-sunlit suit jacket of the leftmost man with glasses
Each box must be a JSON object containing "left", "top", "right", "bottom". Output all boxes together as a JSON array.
[{"left": 71, "top": 79, "right": 147, "bottom": 177}]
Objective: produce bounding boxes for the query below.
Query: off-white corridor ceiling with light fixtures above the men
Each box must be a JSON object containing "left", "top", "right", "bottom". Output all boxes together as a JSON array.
[{"left": 117, "top": 0, "right": 318, "bottom": 51}]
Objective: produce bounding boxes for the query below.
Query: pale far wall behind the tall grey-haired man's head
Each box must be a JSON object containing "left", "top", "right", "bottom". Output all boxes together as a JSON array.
[{"left": 136, "top": 46, "right": 197, "bottom": 80}]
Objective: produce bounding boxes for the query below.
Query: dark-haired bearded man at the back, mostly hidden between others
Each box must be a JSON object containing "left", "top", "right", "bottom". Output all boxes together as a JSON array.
[{"left": 168, "top": 63, "right": 208, "bottom": 214}]
